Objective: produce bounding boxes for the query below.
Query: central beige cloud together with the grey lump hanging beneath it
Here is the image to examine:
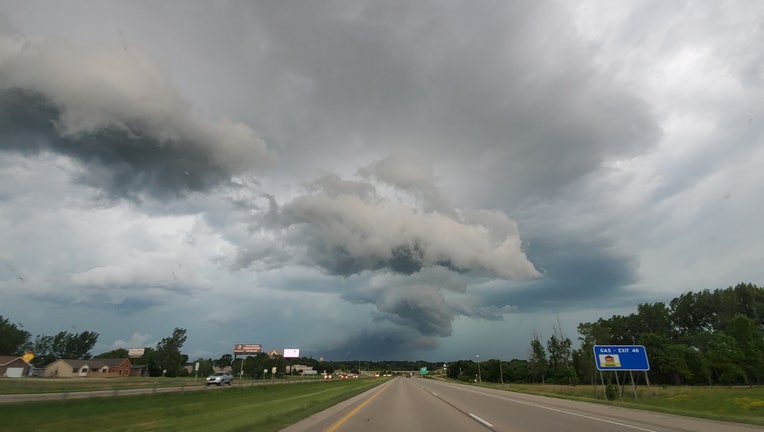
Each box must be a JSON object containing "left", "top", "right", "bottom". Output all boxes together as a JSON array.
[{"left": 234, "top": 155, "right": 540, "bottom": 340}]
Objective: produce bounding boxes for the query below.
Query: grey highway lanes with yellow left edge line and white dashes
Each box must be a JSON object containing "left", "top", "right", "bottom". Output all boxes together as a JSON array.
[{"left": 283, "top": 378, "right": 764, "bottom": 432}]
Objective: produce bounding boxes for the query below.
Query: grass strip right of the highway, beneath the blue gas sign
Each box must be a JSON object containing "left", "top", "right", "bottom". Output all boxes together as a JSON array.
[{"left": 482, "top": 383, "right": 764, "bottom": 426}]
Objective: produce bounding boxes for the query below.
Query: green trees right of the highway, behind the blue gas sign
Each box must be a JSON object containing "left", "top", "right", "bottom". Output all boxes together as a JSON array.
[{"left": 448, "top": 283, "right": 764, "bottom": 385}]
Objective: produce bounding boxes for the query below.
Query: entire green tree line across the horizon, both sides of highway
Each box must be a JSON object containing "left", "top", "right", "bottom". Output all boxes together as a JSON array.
[{"left": 0, "top": 283, "right": 764, "bottom": 385}]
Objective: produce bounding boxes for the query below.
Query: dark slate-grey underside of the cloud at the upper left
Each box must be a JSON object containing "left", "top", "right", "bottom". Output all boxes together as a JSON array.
[{"left": 0, "top": 89, "right": 236, "bottom": 198}]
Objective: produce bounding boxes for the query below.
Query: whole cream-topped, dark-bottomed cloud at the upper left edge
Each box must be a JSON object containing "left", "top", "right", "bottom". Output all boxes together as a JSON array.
[{"left": 0, "top": 35, "right": 274, "bottom": 197}]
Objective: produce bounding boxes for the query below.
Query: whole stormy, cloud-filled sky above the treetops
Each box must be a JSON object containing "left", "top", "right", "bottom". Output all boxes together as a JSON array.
[{"left": 0, "top": 0, "right": 764, "bottom": 361}]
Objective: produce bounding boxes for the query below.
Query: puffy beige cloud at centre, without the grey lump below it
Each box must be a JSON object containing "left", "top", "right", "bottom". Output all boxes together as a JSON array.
[{"left": 254, "top": 157, "right": 539, "bottom": 279}]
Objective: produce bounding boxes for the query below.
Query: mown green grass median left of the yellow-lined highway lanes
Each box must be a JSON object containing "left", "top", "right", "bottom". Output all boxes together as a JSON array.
[{"left": 0, "top": 378, "right": 385, "bottom": 432}]
